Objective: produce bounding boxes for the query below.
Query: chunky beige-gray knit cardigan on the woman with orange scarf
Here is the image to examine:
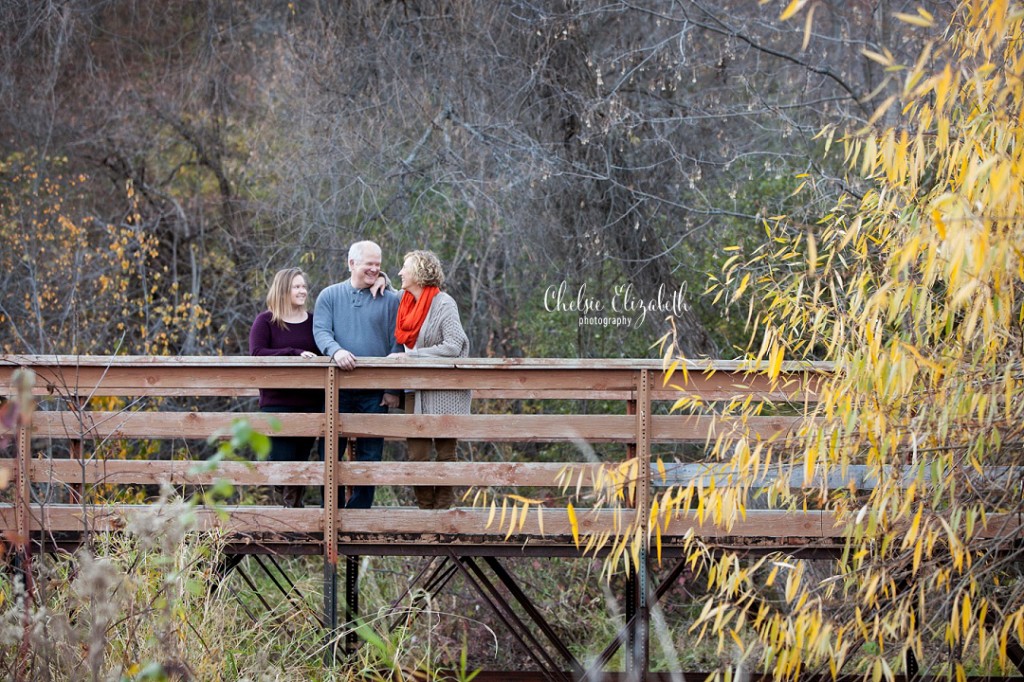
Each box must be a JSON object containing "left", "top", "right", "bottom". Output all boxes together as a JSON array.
[{"left": 408, "top": 292, "right": 472, "bottom": 415}]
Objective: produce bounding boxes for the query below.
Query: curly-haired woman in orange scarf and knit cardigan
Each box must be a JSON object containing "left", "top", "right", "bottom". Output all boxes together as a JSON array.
[{"left": 390, "top": 251, "right": 471, "bottom": 509}]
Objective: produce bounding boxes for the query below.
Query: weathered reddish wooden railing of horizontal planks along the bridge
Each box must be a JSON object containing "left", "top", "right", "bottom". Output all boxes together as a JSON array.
[{"left": 0, "top": 356, "right": 836, "bottom": 556}]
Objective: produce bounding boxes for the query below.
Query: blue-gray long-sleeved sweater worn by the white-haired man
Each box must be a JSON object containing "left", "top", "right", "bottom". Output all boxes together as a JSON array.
[{"left": 313, "top": 281, "right": 402, "bottom": 357}]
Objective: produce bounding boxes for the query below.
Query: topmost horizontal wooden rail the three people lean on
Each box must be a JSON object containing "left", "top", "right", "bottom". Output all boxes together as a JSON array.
[{"left": 0, "top": 355, "right": 830, "bottom": 402}]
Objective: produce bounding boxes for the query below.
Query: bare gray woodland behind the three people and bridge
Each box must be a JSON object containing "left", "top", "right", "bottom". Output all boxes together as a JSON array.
[{"left": 0, "top": 0, "right": 921, "bottom": 357}]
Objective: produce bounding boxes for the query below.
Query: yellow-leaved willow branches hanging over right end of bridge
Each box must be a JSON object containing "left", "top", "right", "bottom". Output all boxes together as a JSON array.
[{"left": 667, "top": 1, "right": 1024, "bottom": 680}]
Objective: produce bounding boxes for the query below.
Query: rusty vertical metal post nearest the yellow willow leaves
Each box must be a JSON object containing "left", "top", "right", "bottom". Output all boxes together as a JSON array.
[{"left": 626, "top": 370, "right": 650, "bottom": 680}]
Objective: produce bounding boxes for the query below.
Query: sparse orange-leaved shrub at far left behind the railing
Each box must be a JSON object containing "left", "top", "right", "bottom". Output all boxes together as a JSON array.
[{"left": 0, "top": 154, "right": 211, "bottom": 355}]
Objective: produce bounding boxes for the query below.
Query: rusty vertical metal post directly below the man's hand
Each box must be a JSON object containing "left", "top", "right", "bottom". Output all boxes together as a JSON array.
[{"left": 323, "top": 363, "right": 338, "bottom": 666}]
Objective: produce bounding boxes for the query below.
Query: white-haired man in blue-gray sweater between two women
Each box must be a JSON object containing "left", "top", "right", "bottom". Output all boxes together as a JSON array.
[{"left": 313, "top": 242, "right": 399, "bottom": 509}]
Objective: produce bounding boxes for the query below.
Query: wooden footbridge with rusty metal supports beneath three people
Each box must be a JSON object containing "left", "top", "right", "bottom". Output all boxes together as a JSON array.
[{"left": 0, "top": 356, "right": 1015, "bottom": 680}]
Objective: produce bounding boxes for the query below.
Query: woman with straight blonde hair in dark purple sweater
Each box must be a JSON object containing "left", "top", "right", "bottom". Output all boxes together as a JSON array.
[{"left": 249, "top": 267, "right": 324, "bottom": 507}]
